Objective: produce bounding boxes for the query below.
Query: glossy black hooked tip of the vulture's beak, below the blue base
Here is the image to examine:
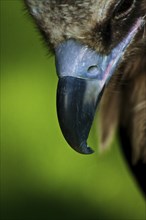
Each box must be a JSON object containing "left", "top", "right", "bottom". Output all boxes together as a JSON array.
[{"left": 57, "top": 76, "right": 104, "bottom": 154}]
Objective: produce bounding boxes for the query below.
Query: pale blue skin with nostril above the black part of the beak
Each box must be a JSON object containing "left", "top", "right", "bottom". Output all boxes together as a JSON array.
[{"left": 55, "top": 18, "right": 144, "bottom": 85}]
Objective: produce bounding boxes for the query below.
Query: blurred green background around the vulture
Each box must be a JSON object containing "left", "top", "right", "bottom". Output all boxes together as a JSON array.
[{"left": 0, "top": 0, "right": 146, "bottom": 220}]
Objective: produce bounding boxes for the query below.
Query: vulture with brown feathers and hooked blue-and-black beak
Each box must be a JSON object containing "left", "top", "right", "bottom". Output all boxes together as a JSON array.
[{"left": 24, "top": 0, "right": 146, "bottom": 196}]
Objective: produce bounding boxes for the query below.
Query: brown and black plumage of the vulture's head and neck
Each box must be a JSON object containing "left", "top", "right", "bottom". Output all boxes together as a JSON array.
[{"left": 25, "top": 0, "right": 146, "bottom": 194}]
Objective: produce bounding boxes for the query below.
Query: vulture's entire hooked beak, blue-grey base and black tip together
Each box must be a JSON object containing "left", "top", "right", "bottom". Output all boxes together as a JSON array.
[{"left": 55, "top": 19, "right": 143, "bottom": 154}]
